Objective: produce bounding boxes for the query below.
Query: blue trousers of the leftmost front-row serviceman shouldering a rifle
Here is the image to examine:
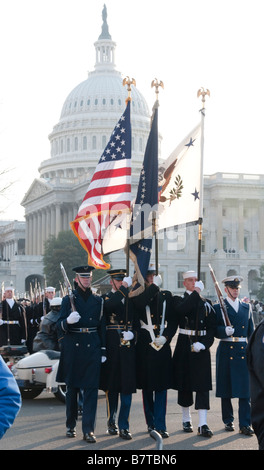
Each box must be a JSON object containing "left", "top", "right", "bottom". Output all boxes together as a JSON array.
[{"left": 66, "top": 386, "right": 98, "bottom": 434}]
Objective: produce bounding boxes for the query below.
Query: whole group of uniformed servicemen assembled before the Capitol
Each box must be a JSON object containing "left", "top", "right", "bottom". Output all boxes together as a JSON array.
[{"left": 0, "top": 265, "right": 263, "bottom": 448}]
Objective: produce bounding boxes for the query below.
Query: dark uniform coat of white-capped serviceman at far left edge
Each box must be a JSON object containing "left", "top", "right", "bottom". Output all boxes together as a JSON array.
[{"left": 0, "top": 300, "right": 27, "bottom": 346}]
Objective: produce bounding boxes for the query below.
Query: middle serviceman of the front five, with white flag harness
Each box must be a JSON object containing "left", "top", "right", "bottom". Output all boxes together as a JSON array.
[{"left": 131, "top": 264, "right": 175, "bottom": 438}]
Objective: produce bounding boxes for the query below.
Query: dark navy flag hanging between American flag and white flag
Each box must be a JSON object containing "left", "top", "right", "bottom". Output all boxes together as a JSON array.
[{"left": 130, "top": 103, "right": 158, "bottom": 285}]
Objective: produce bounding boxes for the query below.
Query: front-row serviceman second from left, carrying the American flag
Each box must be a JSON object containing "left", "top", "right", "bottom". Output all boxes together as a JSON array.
[{"left": 100, "top": 269, "right": 137, "bottom": 439}]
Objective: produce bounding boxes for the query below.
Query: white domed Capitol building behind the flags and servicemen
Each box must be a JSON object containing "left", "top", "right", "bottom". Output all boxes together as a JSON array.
[{"left": 0, "top": 7, "right": 264, "bottom": 299}]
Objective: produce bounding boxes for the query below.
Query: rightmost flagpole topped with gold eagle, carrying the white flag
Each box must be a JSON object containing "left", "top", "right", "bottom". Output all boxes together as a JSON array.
[{"left": 197, "top": 88, "right": 210, "bottom": 279}]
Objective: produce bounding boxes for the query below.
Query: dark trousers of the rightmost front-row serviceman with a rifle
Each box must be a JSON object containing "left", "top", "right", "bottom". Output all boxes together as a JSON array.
[{"left": 221, "top": 398, "right": 251, "bottom": 429}]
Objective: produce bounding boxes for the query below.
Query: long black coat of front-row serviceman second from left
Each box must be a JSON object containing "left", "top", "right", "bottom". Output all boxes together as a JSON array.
[{"left": 100, "top": 286, "right": 138, "bottom": 394}]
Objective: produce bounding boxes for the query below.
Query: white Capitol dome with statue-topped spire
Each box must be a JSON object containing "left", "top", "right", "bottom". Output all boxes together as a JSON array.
[{"left": 39, "top": 6, "right": 156, "bottom": 184}]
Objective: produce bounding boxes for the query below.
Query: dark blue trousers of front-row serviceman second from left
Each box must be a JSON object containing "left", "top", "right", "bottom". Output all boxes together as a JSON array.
[{"left": 106, "top": 391, "right": 132, "bottom": 429}]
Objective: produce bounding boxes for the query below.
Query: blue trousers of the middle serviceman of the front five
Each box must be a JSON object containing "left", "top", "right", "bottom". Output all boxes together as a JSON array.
[{"left": 142, "top": 390, "right": 167, "bottom": 431}]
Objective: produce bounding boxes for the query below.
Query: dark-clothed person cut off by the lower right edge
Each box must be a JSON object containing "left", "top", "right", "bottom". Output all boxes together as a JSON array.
[{"left": 247, "top": 320, "right": 264, "bottom": 450}]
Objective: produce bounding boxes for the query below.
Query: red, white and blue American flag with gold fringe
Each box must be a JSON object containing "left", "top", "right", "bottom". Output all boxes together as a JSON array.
[{"left": 70, "top": 101, "right": 131, "bottom": 269}]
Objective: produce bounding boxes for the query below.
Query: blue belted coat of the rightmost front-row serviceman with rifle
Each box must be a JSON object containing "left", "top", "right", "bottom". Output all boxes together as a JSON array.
[{"left": 215, "top": 299, "right": 254, "bottom": 398}]
